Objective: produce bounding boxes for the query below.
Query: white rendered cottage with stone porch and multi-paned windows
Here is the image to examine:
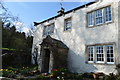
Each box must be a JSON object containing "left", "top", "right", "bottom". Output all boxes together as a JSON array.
[{"left": 32, "top": 0, "right": 120, "bottom": 74}]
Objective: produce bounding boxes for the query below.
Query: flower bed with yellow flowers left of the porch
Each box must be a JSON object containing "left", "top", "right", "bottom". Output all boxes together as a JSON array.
[{"left": 0, "top": 65, "right": 40, "bottom": 78}]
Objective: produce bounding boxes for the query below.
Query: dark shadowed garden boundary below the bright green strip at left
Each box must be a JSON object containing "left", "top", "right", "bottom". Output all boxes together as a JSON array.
[{"left": 2, "top": 50, "right": 31, "bottom": 68}]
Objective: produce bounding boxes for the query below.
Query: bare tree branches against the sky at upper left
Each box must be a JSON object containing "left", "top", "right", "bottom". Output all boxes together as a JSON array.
[{"left": 0, "top": 1, "right": 24, "bottom": 30}]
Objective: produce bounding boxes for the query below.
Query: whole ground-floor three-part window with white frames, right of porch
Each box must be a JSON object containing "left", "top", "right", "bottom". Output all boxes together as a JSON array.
[{"left": 86, "top": 44, "right": 114, "bottom": 64}]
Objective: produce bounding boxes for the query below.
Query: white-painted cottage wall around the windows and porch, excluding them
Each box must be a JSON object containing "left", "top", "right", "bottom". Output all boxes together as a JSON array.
[{"left": 33, "top": 0, "right": 120, "bottom": 74}]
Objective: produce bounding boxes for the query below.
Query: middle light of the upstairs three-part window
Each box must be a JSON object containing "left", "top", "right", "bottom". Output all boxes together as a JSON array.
[{"left": 95, "top": 9, "right": 103, "bottom": 25}]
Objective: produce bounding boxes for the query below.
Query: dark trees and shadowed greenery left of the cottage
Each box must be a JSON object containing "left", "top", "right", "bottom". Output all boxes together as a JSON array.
[{"left": 2, "top": 26, "right": 33, "bottom": 67}]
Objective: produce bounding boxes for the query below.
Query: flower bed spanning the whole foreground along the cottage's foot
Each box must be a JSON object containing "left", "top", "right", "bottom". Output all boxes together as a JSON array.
[{"left": 3, "top": 65, "right": 120, "bottom": 80}]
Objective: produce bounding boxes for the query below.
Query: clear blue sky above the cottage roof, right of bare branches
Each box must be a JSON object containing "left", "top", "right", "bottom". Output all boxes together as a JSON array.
[{"left": 4, "top": 2, "right": 93, "bottom": 31}]
